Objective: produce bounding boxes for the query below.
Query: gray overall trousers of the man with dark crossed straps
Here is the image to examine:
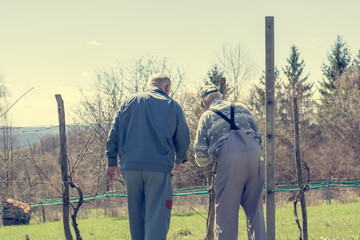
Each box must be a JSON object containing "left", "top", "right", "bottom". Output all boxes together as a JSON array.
[{"left": 215, "top": 130, "right": 266, "bottom": 240}]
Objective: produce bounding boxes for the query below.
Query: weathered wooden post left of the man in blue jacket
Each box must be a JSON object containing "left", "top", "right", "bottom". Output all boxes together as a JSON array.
[{"left": 55, "top": 94, "right": 73, "bottom": 240}]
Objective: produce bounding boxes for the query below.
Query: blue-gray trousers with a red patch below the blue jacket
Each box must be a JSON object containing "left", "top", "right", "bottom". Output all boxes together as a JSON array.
[{"left": 122, "top": 170, "right": 173, "bottom": 240}]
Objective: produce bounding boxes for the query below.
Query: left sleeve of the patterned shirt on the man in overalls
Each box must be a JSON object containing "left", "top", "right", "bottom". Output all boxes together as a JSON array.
[{"left": 194, "top": 115, "right": 212, "bottom": 167}]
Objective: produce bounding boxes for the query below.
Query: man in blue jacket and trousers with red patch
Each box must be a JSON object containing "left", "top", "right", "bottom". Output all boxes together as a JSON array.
[{"left": 106, "top": 73, "right": 190, "bottom": 240}]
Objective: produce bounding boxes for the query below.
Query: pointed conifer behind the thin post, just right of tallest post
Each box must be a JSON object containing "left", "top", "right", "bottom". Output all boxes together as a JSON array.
[{"left": 278, "top": 45, "right": 315, "bottom": 181}]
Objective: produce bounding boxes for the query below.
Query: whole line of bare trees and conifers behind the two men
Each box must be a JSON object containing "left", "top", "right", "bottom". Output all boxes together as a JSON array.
[{"left": 0, "top": 36, "right": 360, "bottom": 208}]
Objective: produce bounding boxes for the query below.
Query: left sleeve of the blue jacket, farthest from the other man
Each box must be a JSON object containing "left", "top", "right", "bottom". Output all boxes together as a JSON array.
[{"left": 106, "top": 112, "right": 120, "bottom": 166}]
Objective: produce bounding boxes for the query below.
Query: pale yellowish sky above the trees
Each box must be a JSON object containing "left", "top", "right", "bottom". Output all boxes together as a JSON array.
[{"left": 0, "top": 0, "right": 360, "bottom": 127}]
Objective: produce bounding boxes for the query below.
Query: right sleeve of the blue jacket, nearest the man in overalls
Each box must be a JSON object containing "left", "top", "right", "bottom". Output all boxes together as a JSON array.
[{"left": 173, "top": 106, "right": 190, "bottom": 164}]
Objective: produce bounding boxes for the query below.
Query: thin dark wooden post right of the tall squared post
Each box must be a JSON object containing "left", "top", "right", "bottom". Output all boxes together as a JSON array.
[{"left": 293, "top": 97, "right": 308, "bottom": 240}]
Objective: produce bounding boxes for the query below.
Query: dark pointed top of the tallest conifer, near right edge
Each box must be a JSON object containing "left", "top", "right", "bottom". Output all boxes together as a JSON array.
[{"left": 320, "top": 36, "right": 351, "bottom": 96}]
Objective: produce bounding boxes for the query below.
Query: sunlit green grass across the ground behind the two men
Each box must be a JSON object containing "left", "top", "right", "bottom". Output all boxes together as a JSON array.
[{"left": 0, "top": 202, "right": 360, "bottom": 240}]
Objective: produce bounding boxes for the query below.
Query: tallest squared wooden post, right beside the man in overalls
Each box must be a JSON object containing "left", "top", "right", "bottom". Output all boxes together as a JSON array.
[{"left": 265, "top": 17, "right": 275, "bottom": 240}]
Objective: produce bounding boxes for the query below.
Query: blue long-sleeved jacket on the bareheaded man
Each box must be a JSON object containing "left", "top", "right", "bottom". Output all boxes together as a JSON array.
[{"left": 106, "top": 88, "right": 190, "bottom": 172}]
